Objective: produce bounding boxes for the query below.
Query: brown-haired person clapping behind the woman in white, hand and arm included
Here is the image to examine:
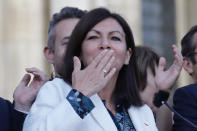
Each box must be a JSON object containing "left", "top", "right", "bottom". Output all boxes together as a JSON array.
[{"left": 136, "top": 45, "right": 183, "bottom": 131}]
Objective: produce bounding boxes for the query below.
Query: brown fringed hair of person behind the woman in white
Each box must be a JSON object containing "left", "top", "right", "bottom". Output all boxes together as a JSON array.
[{"left": 135, "top": 46, "right": 160, "bottom": 91}]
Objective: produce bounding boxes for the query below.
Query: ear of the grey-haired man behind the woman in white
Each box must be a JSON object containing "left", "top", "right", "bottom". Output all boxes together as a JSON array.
[{"left": 43, "top": 46, "right": 54, "bottom": 64}]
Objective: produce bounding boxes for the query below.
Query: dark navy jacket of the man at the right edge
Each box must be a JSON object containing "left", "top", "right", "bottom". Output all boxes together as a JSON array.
[{"left": 173, "top": 83, "right": 197, "bottom": 131}]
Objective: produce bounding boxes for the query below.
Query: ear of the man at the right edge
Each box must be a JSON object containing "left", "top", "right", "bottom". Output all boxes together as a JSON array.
[{"left": 183, "top": 57, "right": 194, "bottom": 75}]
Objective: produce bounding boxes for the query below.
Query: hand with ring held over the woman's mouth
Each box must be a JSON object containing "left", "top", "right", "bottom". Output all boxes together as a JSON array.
[{"left": 72, "top": 49, "right": 116, "bottom": 97}]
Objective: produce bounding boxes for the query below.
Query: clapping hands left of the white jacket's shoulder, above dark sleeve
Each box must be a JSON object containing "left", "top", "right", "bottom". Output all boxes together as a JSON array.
[{"left": 14, "top": 68, "right": 47, "bottom": 111}]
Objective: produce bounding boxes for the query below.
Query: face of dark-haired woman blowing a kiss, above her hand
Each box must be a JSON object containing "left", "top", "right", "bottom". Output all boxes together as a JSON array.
[{"left": 81, "top": 18, "right": 131, "bottom": 70}]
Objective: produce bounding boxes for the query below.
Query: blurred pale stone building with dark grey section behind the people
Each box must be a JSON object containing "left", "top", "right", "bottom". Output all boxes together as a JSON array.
[{"left": 0, "top": 0, "right": 197, "bottom": 100}]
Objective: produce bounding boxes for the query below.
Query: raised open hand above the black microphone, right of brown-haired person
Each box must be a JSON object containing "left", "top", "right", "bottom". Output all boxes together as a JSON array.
[{"left": 155, "top": 45, "right": 183, "bottom": 91}]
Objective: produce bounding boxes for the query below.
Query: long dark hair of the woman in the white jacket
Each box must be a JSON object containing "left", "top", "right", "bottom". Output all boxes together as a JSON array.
[{"left": 58, "top": 8, "right": 142, "bottom": 108}]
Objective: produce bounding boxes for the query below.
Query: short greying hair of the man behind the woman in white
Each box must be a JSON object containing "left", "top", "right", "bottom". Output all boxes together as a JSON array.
[{"left": 48, "top": 7, "right": 86, "bottom": 51}]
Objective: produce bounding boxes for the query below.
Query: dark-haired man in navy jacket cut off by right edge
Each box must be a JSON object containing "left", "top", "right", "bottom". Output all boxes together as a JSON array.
[{"left": 173, "top": 26, "right": 197, "bottom": 131}]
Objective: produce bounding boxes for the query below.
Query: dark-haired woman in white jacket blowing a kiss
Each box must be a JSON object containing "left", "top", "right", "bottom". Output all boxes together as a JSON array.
[{"left": 24, "top": 8, "right": 157, "bottom": 131}]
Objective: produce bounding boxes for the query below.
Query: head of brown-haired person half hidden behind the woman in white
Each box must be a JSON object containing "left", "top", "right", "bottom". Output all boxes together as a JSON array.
[{"left": 136, "top": 46, "right": 163, "bottom": 113}]
